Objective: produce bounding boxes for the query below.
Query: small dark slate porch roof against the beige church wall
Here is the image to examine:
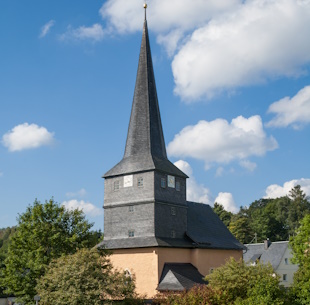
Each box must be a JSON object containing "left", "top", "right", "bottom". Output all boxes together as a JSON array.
[{"left": 157, "top": 263, "right": 207, "bottom": 291}]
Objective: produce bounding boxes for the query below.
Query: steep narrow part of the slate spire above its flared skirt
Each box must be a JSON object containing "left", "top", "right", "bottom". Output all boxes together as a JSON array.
[{"left": 124, "top": 20, "right": 167, "bottom": 159}]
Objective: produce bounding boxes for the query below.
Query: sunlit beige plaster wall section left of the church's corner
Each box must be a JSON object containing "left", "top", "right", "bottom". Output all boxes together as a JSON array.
[{"left": 110, "top": 248, "right": 159, "bottom": 298}]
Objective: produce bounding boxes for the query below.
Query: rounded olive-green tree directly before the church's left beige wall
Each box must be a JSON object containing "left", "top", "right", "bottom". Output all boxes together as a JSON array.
[{"left": 37, "top": 249, "right": 135, "bottom": 305}]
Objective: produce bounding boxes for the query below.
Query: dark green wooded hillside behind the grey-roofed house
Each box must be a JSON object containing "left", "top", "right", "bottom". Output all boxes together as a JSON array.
[{"left": 213, "top": 185, "right": 310, "bottom": 244}]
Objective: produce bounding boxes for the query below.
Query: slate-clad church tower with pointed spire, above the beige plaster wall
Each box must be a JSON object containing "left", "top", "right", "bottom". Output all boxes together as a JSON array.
[{"left": 104, "top": 15, "right": 187, "bottom": 247}]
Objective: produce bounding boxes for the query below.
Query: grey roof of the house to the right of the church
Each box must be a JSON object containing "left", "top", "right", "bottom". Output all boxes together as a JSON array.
[{"left": 243, "top": 241, "right": 289, "bottom": 270}]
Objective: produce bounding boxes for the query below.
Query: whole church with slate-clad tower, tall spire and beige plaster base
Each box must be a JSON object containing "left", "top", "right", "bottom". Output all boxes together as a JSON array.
[{"left": 101, "top": 5, "right": 243, "bottom": 298}]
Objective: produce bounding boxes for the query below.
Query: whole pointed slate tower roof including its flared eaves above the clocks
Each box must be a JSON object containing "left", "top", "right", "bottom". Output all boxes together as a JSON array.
[{"left": 103, "top": 20, "right": 187, "bottom": 178}]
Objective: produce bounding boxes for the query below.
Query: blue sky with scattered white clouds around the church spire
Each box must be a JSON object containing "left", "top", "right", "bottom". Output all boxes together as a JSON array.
[{"left": 0, "top": 0, "right": 310, "bottom": 229}]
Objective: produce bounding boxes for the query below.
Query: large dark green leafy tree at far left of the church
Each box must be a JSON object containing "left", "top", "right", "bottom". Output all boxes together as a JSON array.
[{"left": 0, "top": 199, "right": 98, "bottom": 304}]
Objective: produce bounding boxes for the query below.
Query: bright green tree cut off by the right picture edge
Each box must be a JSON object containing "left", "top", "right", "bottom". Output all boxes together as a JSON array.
[{"left": 290, "top": 214, "right": 310, "bottom": 305}]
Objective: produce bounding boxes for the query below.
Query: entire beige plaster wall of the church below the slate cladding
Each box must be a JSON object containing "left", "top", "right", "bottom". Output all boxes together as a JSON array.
[{"left": 111, "top": 248, "right": 242, "bottom": 298}]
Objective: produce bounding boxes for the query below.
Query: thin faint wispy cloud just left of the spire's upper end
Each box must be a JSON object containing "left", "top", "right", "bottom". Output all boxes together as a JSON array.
[{"left": 60, "top": 23, "right": 106, "bottom": 42}]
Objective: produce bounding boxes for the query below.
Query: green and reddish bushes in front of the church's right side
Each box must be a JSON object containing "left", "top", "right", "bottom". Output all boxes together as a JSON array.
[{"left": 156, "top": 259, "right": 292, "bottom": 305}]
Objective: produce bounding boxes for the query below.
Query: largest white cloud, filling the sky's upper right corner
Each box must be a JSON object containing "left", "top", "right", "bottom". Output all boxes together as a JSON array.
[{"left": 172, "top": 0, "right": 310, "bottom": 102}]
